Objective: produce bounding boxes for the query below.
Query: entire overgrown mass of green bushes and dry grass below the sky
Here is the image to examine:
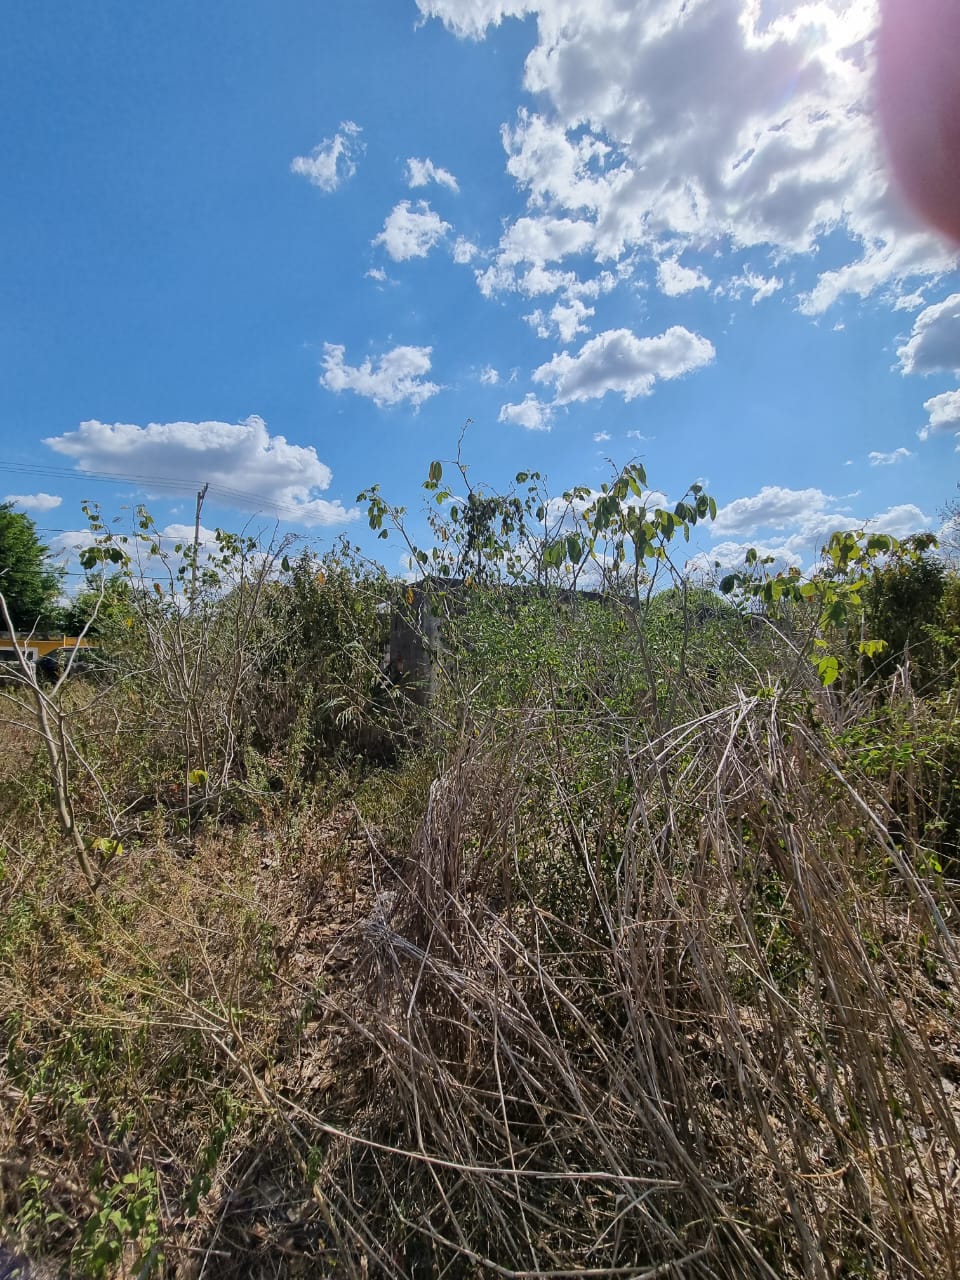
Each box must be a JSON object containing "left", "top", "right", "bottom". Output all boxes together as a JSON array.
[{"left": 0, "top": 463, "right": 960, "bottom": 1280}]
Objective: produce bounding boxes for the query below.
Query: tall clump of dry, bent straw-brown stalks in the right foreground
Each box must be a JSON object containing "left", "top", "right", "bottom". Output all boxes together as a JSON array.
[{"left": 291, "top": 699, "right": 960, "bottom": 1277}]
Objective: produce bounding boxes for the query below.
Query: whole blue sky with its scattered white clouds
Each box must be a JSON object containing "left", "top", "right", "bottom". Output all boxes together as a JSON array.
[{"left": 0, "top": 0, "right": 960, "bottom": 588}]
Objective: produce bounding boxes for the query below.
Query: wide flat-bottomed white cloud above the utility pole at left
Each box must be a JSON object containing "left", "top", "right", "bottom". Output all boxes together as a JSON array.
[{"left": 44, "top": 417, "right": 357, "bottom": 526}]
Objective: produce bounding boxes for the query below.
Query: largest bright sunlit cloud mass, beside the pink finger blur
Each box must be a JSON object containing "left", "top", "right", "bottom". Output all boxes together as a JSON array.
[{"left": 417, "top": 0, "right": 955, "bottom": 314}]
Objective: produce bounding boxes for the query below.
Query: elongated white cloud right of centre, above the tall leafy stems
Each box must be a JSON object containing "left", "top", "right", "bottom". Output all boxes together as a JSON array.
[{"left": 534, "top": 325, "right": 716, "bottom": 404}]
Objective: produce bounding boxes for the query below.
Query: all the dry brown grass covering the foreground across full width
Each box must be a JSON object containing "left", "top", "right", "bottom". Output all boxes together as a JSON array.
[{"left": 0, "top": 675, "right": 960, "bottom": 1280}]
